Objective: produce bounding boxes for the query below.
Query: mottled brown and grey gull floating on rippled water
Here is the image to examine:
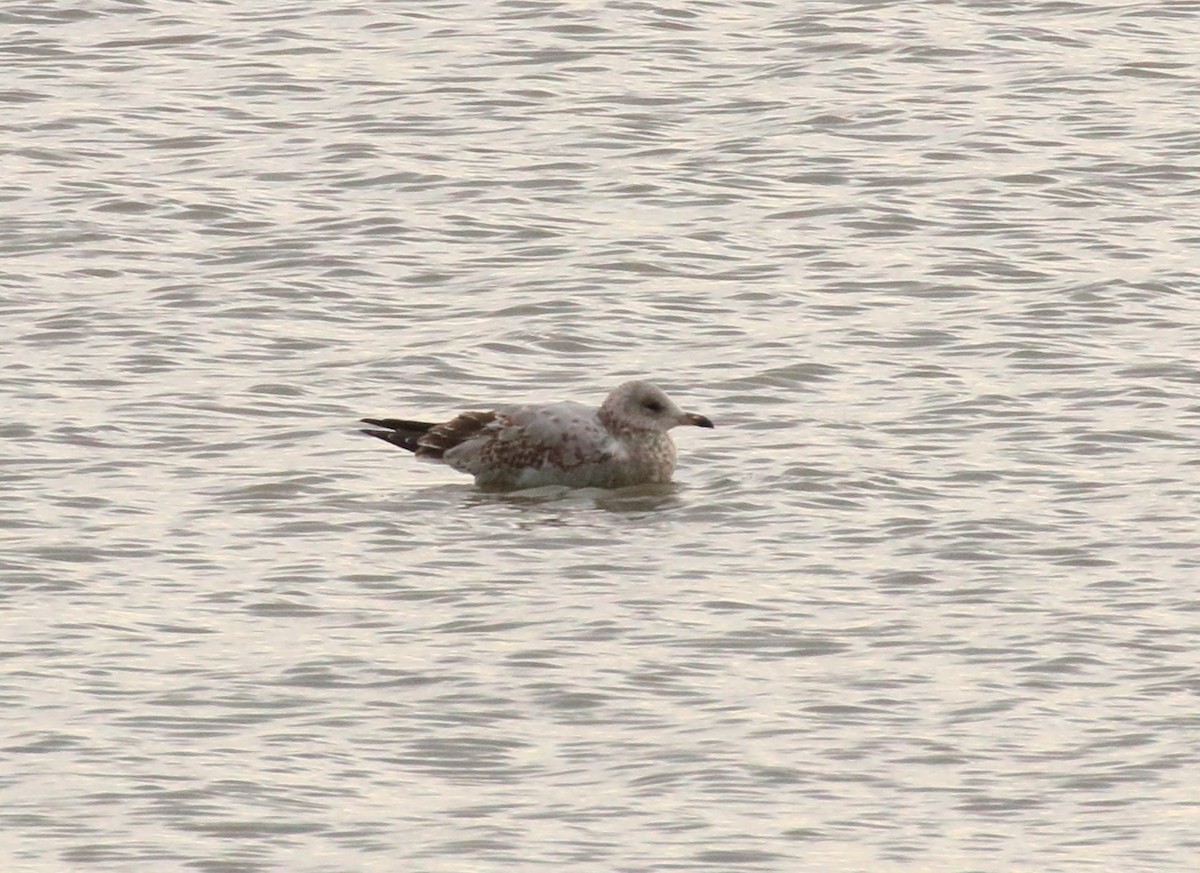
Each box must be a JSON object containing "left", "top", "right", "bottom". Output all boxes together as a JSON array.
[{"left": 362, "top": 381, "right": 713, "bottom": 490}]
